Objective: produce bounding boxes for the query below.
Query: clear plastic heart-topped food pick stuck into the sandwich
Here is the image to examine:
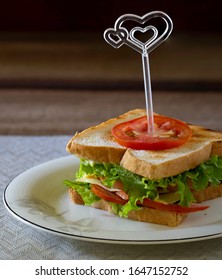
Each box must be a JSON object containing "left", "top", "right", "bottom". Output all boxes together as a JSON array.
[{"left": 104, "top": 11, "right": 173, "bottom": 134}]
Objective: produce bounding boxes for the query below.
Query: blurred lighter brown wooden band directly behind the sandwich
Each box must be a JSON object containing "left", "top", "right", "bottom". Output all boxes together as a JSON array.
[{"left": 0, "top": 89, "right": 222, "bottom": 135}]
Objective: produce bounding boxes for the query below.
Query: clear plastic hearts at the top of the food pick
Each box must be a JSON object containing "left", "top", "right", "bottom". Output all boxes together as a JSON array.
[{"left": 104, "top": 11, "right": 173, "bottom": 53}]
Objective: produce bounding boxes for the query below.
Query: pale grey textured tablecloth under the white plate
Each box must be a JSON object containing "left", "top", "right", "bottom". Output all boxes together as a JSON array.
[{"left": 0, "top": 135, "right": 222, "bottom": 260}]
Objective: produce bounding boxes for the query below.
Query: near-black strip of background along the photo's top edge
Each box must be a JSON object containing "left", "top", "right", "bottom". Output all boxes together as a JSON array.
[{"left": 0, "top": 0, "right": 221, "bottom": 33}]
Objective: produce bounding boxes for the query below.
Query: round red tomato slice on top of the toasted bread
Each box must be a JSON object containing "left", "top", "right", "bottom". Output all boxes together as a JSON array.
[{"left": 112, "top": 115, "right": 192, "bottom": 150}]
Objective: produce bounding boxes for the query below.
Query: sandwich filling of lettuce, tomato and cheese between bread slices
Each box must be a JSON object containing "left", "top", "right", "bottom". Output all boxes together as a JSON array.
[{"left": 65, "top": 156, "right": 222, "bottom": 215}]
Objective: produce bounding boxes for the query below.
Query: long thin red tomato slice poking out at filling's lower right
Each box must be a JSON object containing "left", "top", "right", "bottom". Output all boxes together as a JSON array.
[{"left": 138, "top": 198, "right": 209, "bottom": 213}]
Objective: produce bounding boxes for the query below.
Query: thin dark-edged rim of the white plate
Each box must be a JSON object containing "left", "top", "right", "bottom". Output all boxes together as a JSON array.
[{"left": 3, "top": 155, "right": 222, "bottom": 245}]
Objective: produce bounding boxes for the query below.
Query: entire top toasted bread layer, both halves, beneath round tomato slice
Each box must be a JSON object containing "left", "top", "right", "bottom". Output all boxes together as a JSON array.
[{"left": 67, "top": 109, "right": 222, "bottom": 180}]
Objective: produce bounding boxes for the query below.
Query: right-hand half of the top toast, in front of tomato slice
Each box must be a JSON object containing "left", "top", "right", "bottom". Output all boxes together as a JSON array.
[{"left": 120, "top": 125, "right": 222, "bottom": 180}]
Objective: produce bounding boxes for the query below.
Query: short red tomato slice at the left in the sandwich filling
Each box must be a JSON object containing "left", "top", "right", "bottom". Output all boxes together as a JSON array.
[{"left": 91, "top": 185, "right": 127, "bottom": 205}]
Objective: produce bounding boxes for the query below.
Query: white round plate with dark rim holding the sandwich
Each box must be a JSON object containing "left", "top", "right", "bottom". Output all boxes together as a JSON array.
[{"left": 4, "top": 156, "right": 222, "bottom": 244}]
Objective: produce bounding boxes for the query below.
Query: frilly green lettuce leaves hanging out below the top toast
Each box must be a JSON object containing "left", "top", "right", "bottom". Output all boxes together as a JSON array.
[{"left": 65, "top": 156, "right": 222, "bottom": 217}]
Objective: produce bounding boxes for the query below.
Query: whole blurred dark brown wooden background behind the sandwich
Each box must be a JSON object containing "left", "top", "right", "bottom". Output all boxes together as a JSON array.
[{"left": 0, "top": 0, "right": 222, "bottom": 135}]
